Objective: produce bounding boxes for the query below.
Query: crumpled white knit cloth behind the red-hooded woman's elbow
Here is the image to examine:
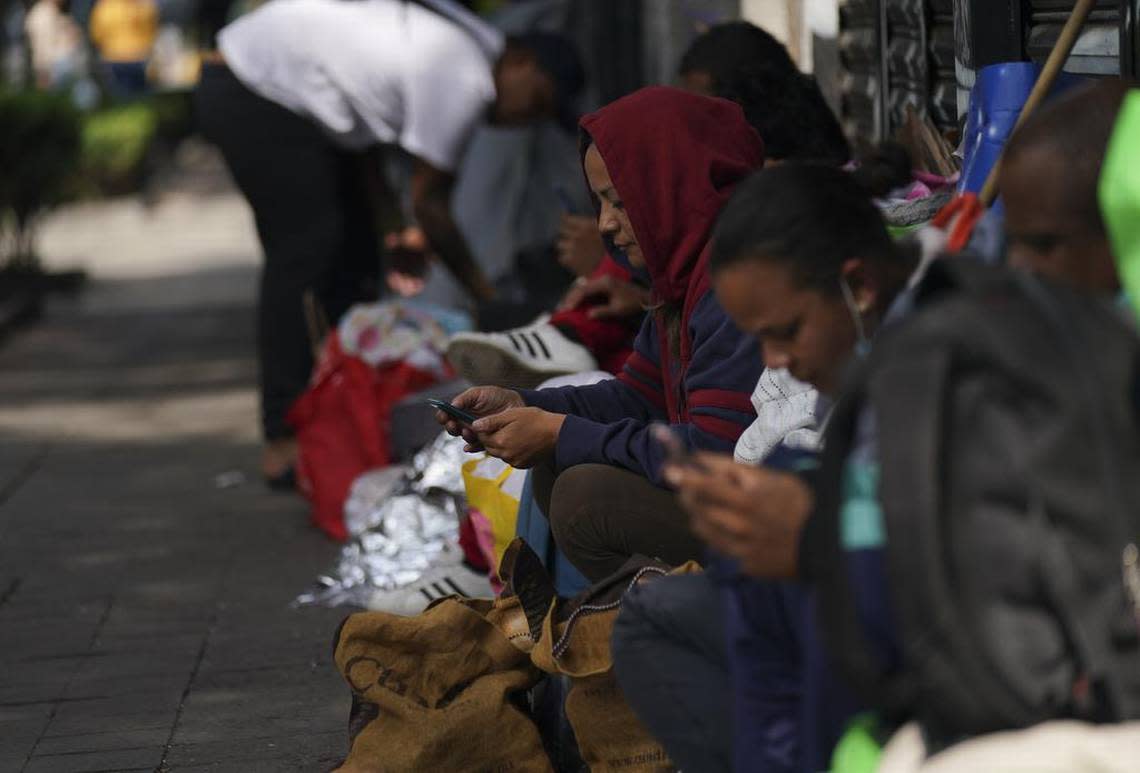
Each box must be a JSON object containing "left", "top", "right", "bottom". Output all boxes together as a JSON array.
[{"left": 735, "top": 368, "right": 820, "bottom": 464}]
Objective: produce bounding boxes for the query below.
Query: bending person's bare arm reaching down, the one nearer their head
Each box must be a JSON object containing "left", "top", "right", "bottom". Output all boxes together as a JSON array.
[{"left": 412, "top": 158, "right": 495, "bottom": 300}]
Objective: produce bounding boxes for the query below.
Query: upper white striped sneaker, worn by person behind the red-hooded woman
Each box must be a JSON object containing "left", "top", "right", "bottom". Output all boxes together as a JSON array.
[{"left": 447, "top": 322, "right": 597, "bottom": 389}]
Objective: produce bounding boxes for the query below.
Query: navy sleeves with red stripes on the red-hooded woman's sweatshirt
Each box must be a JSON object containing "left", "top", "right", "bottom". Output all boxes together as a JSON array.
[{"left": 522, "top": 293, "right": 763, "bottom": 485}]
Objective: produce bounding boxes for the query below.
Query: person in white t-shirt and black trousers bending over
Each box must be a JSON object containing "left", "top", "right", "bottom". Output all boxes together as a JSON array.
[{"left": 195, "top": 0, "right": 583, "bottom": 482}]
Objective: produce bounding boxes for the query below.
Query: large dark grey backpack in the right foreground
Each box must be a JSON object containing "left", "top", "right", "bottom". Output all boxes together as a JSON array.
[{"left": 805, "top": 259, "right": 1140, "bottom": 742}]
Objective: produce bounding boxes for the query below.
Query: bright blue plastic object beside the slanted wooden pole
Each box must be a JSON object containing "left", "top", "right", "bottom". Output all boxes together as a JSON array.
[{"left": 958, "top": 62, "right": 1086, "bottom": 212}]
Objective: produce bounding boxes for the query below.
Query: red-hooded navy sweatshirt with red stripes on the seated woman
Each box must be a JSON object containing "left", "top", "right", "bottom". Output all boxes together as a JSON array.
[{"left": 522, "top": 87, "right": 764, "bottom": 482}]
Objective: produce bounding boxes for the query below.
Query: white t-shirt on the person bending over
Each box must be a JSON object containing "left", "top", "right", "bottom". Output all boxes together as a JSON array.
[{"left": 218, "top": 0, "right": 504, "bottom": 171}]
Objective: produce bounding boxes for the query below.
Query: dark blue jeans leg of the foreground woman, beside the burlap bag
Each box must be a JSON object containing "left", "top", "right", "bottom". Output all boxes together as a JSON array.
[{"left": 612, "top": 575, "right": 732, "bottom": 773}]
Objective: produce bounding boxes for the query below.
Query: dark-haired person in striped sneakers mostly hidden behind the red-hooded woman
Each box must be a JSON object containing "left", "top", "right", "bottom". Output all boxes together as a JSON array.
[{"left": 447, "top": 22, "right": 848, "bottom": 388}]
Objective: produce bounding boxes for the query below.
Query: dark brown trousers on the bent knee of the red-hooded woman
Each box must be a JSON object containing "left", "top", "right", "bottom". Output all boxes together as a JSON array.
[{"left": 532, "top": 464, "right": 703, "bottom": 583}]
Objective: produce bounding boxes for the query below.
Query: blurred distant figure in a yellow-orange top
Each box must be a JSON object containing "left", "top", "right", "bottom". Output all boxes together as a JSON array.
[{"left": 90, "top": 0, "right": 158, "bottom": 99}]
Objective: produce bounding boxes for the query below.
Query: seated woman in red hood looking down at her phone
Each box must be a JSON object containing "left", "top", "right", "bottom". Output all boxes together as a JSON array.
[{"left": 438, "top": 87, "right": 764, "bottom": 580}]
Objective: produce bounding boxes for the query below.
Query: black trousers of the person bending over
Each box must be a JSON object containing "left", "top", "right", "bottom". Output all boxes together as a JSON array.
[{"left": 195, "top": 64, "right": 380, "bottom": 440}]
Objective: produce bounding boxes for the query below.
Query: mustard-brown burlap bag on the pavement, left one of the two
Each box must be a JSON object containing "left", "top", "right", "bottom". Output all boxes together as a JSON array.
[{"left": 335, "top": 597, "right": 552, "bottom": 773}]
